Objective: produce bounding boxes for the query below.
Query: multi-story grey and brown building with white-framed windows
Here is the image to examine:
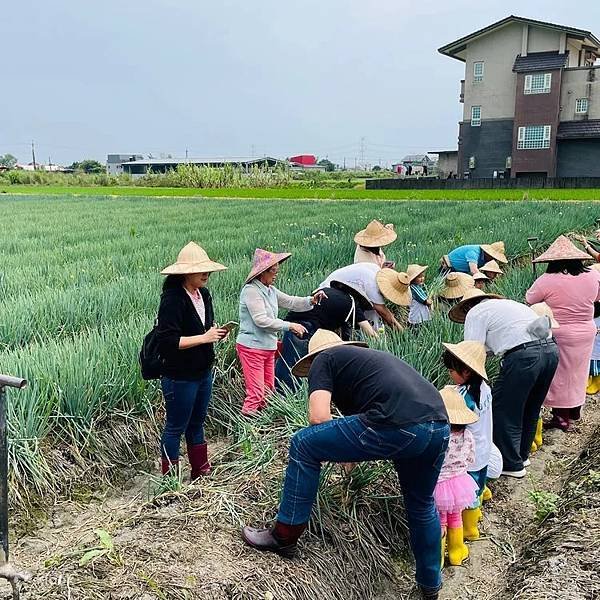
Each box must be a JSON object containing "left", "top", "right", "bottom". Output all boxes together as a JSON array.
[{"left": 439, "top": 16, "right": 600, "bottom": 178}]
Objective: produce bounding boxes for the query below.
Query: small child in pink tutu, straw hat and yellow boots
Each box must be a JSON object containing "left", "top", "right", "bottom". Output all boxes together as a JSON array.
[{"left": 433, "top": 385, "right": 478, "bottom": 566}]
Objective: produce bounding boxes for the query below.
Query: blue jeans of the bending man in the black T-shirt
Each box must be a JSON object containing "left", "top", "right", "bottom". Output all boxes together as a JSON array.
[{"left": 277, "top": 415, "right": 450, "bottom": 588}]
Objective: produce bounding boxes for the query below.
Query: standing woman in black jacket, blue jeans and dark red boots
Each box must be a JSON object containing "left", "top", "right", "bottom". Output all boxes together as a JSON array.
[{"left": 157, "top": 242, "right": 227, "bottom": 480}]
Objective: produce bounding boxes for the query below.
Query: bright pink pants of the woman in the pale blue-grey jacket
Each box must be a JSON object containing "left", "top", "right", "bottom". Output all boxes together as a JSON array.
[{"left": 235, "top": 344, "right": 277, "bottom": 414}]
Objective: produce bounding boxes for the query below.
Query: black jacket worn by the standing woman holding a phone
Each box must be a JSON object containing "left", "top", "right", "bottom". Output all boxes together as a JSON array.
[{"left": 157, "top": 285, "right": 215, "bottom": 381}]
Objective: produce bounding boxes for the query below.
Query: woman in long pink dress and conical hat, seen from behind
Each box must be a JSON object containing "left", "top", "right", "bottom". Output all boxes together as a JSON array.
[{"left": 525, "top": 235, "right": 600, "bottom": 431}]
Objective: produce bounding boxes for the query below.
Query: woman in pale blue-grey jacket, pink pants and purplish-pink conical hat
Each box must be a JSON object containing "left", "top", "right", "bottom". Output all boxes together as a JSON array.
[{"left": 236, "top": 248, "right": 325, "bottom": 416}]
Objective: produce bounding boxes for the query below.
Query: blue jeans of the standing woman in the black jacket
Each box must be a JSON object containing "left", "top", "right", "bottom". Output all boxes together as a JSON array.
[{"left": 160, "top": 369, "right": 212, "bottom": 462}]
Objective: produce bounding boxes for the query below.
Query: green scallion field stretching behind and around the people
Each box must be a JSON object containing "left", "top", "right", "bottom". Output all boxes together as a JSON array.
[{"left": 0, "top": 195, "right": 598, "bottom": 500}]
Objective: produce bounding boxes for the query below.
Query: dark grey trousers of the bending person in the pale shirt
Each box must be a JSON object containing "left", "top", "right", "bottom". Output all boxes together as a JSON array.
[{"left": 492, "top": 339, "right": 558, "bottom": 471}]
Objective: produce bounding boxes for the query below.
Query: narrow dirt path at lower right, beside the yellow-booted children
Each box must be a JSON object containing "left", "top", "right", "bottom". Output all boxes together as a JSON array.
[{"left": 441, "top": 397, "right": 600, "bottom": 600}]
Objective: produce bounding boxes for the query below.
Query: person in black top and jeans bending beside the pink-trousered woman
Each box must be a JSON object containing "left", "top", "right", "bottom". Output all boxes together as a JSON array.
[{"left": 275, "top": 281, "right": 377, "bottom": 393}]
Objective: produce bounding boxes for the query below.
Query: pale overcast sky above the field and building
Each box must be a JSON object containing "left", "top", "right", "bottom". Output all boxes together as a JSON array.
[{"left": 0, "top": 0, "right": 600, "bottom": 164}]
